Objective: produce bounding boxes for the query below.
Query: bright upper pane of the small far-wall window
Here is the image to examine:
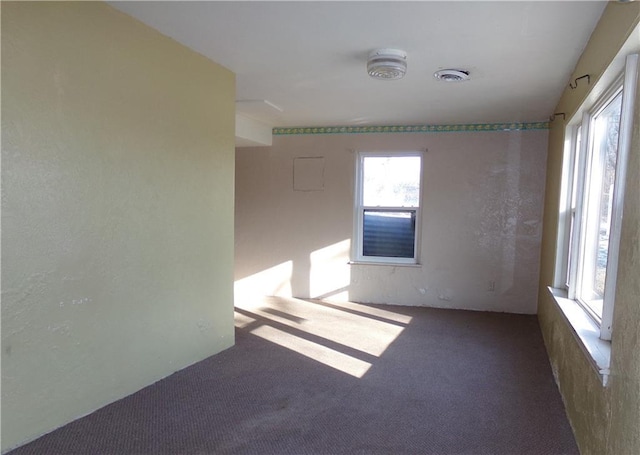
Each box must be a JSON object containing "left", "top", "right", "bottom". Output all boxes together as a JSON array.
[{"left": 362, "top": 156, "right": 420, "bottom": 207}]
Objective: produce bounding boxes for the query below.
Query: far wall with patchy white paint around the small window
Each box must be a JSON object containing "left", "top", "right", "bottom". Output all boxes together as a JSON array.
[{"left": 235, "top": 130, "right": 548, "bottom": 313}]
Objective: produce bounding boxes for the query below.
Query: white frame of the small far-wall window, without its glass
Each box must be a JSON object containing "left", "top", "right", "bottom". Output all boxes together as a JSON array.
[{"left": 352, "top": 151, "right": 424, "bottom": 265}]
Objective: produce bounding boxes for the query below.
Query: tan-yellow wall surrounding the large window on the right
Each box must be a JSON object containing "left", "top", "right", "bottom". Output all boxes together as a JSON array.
[{"left": 538, "top": 3, "right": 640, "bottom": 455}]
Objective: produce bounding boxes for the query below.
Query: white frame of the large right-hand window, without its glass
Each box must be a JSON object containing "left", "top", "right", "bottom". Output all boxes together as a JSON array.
[{"left": 554, "top": 54, "right": 638, "bottom": 346}]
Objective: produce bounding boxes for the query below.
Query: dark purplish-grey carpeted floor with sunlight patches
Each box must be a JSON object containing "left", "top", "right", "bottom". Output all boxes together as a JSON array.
[{"left": 10, "top": 298, "right": 578, "bottom": 455}]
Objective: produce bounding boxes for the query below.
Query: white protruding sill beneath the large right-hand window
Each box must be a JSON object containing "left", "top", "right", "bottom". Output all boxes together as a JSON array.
[{"left": 547, "top": 286, "right": 611, "bottom": 386}]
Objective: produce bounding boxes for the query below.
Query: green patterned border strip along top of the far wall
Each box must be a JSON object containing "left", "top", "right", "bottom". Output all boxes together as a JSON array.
[{"left": 273, "top": 122, "right": 549, "bottom": 136}]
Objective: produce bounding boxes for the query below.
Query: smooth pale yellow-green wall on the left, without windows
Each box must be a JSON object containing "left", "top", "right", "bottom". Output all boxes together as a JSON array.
[{"left": 2, "top": 2, "right": 235, "bottom": 450}]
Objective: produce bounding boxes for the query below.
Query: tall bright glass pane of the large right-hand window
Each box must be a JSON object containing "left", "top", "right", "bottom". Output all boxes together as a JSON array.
[{"left": 580, "top": 89, "right": 622, "bottom": 317}]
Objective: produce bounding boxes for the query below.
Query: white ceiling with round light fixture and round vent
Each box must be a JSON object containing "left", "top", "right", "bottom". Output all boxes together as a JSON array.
[{"left": 111, "top": 0, "right": 606, "bottom": 127}]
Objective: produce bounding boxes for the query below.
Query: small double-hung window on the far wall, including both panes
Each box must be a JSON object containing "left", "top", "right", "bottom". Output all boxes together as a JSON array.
[{"left": 354, "top": 152, "right": 422, "bottom": 264}]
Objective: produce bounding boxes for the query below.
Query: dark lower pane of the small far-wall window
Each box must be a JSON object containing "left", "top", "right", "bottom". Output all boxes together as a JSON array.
[{"left": 362, "top": 209, "right": 416, "bottom": 258}]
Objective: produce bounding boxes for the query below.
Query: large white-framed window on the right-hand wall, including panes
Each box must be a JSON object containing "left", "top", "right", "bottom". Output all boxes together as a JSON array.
[{"left": 556, "top": 55, "right": 637, "bottom": 340}]
